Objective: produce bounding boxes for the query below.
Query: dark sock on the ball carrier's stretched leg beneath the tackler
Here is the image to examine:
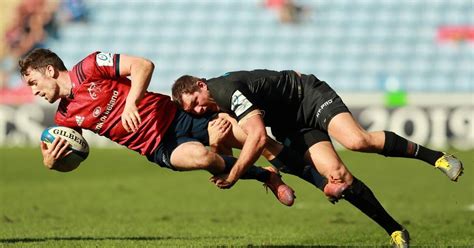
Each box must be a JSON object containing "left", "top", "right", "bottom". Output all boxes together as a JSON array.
[{"left": 269, "top": 146, "right": 327, "bottom": 190}]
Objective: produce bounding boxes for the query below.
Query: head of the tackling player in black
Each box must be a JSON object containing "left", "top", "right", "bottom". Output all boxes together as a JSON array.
[{"left": 171, "top": 75, "right": 219, "bottom": 115}]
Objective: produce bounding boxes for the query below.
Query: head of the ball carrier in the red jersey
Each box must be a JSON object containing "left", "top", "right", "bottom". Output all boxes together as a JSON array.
[{"left": 18, "top": 48, "right": 67, "bottom": 103}]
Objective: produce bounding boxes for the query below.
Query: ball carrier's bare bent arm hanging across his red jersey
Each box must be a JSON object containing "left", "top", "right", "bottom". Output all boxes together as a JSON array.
[{"left": 119, "top": 55, "right": 155, "bottom": 132}]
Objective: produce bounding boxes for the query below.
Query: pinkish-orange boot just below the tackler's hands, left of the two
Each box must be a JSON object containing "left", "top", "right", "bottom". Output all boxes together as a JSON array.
[{"left": 263, "top": 166, "right": 296, "bottom": 207}]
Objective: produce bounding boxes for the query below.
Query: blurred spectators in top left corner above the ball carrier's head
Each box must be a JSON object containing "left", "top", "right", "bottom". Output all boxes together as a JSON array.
[{"left": 0, "top": 0, "right": 87, "bottom": 97}]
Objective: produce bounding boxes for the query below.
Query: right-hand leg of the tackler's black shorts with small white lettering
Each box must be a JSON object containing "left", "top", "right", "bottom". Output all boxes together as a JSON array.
[{"left": 298, "top": 75, "right": 350, "bottom": 132}]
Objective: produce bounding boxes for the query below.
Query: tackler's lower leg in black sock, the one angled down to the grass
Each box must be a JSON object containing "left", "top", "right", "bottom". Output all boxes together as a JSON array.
[{"left": 307, "top": 141, "right": 410, "bottom": 243}]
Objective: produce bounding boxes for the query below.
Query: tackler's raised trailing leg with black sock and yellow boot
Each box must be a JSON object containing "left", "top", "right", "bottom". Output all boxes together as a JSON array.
[{"left": 328, "top": 112, "right": 463, "bottom": 181}]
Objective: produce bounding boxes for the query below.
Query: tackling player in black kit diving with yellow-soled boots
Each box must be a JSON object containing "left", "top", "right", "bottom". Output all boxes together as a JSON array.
[{"left": 172, "top": 70, "right": 463, "bottom": 245}]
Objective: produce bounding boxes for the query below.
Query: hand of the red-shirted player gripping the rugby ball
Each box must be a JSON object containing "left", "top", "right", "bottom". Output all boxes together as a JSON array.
[{"left": 40, "top": 137, "right": 72, "bottom": 169}]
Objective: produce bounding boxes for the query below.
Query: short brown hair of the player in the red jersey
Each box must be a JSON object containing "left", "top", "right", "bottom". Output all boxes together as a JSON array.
[{"left": 18, "top": 48, "right": 67, "bottom": 76}]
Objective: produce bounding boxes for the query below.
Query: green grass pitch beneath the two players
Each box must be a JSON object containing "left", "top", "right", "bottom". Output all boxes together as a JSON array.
[{"left": 0, "top": 148, "right": 474, "bottom": 247}]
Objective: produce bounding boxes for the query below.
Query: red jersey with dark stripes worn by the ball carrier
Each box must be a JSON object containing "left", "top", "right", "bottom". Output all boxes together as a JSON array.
[{"left": 55, "top": 52, "right": 177, "bottom": 155}]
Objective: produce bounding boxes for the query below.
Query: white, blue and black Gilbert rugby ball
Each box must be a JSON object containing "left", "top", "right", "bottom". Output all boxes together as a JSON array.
[{"left": 41, "top": 126, "right": 89, "bottom": 163}]
